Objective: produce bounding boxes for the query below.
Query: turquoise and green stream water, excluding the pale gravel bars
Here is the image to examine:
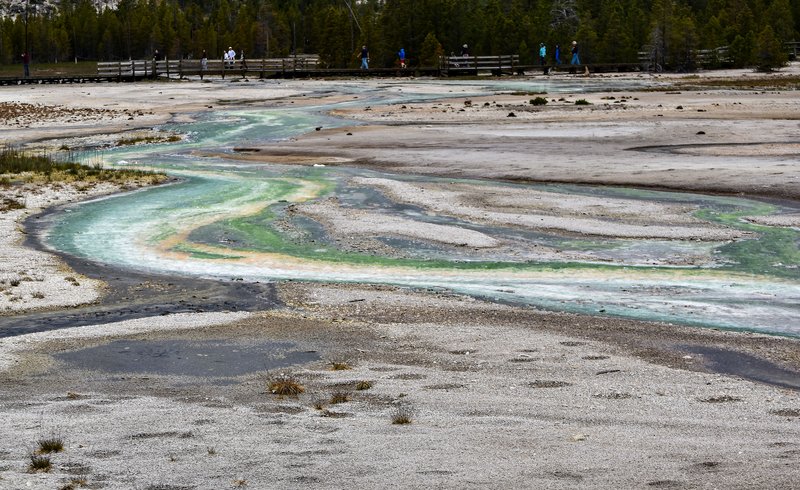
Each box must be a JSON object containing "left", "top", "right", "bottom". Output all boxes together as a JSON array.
[{"left": 40, "top": 80, "right": 800, "bottom": 335}]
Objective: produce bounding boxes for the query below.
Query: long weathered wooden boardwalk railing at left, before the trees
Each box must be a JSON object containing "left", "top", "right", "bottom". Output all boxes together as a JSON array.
[{"left": 97, "top": 55, "right": 319, "bottom": 79}]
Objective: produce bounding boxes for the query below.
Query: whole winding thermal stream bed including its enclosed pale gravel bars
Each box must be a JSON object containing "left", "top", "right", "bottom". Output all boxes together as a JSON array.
[{"left": 44, "top": 82, "right": 800, "bottom": 336}]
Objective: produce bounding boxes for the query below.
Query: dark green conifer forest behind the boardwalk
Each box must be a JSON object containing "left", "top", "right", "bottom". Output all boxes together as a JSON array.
[{"left": 0, "top": 0, "right": 800, "bottom": 69}]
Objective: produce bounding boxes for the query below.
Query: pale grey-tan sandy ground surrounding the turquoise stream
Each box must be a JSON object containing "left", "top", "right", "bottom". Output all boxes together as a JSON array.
[{"left": 0, "top": 67, "right": 800, "bottom": 489}]
